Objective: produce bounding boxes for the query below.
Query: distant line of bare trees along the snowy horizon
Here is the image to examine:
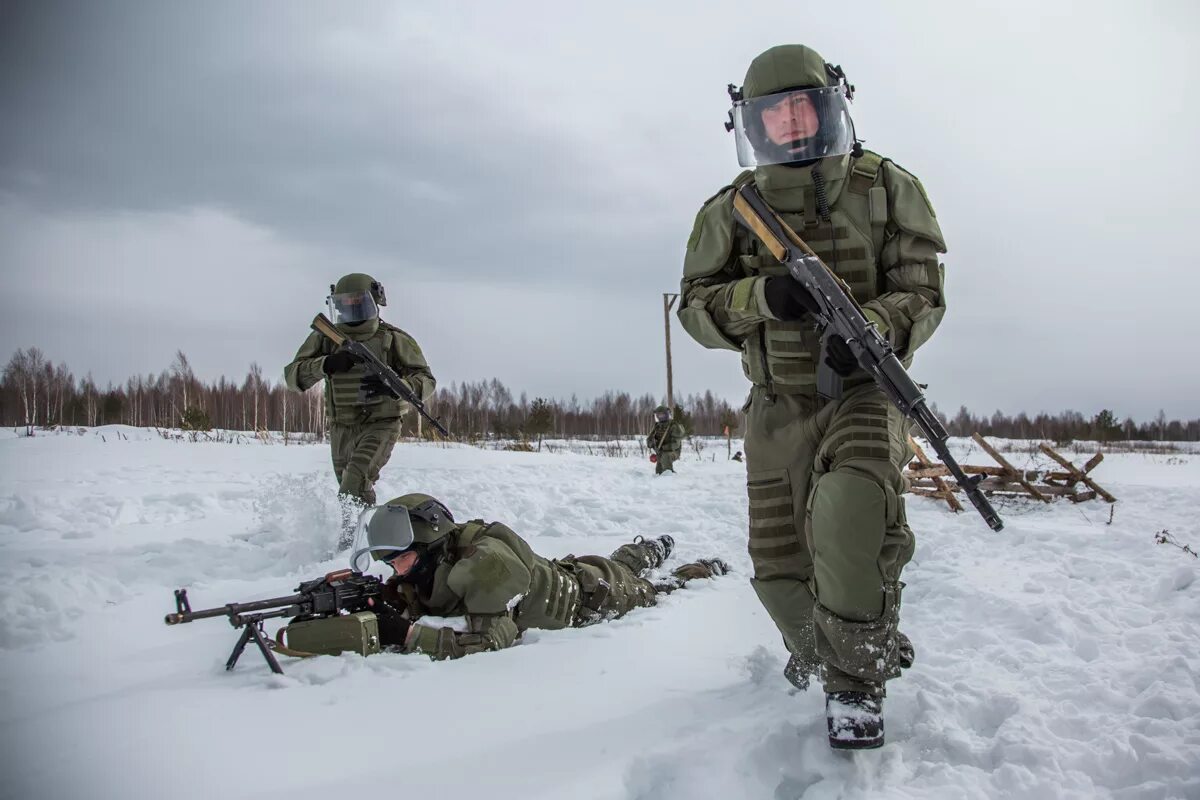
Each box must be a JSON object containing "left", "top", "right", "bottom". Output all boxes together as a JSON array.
[{"left": 0, "top": 348, "right": 1200, "bottom": 443}]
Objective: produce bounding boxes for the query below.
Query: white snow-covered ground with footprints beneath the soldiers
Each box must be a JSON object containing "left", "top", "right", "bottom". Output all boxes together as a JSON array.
[{"left": 0, "top": 427, "right": 1200, "bottom": 800}]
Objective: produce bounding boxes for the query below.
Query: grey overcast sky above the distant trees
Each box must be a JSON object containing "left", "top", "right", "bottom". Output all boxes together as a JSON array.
[{"left": 0, "top": 0, "right": 1200, "bottom": 419}]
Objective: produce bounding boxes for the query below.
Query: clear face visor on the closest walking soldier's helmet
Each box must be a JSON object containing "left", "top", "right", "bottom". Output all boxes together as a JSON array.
[{"left": 733, "top": 86, "right": 854, "bottom": 167}]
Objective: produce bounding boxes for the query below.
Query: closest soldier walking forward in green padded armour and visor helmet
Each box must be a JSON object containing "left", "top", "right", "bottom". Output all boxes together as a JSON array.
[{"left": 678, "top": 44, "right": 946, "bottom": 748}]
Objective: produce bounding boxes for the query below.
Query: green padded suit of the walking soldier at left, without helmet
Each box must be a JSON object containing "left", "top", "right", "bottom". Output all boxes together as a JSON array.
[{"left": 283, "top": 276, "right": 437, "bottom": 505}]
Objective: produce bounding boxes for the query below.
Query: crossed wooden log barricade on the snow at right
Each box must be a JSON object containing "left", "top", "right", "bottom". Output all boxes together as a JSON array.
[{"left": 906, "top": 433, "right": 1117, "bottom": 511}]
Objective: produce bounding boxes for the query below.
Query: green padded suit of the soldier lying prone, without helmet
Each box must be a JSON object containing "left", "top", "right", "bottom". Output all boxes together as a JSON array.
[{"left": 388, "top": 519, "right": 714, "bottom": 660}]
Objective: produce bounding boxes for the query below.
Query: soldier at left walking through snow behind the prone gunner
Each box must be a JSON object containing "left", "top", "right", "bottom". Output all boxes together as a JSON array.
[{"left": 283, "top": 272, "right": 437, "bottom": 548}]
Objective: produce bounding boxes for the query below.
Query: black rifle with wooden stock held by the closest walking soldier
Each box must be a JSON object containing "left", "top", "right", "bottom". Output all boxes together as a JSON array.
[{"left": 733, "top": 184, "right": 1004, "bottom": 530}]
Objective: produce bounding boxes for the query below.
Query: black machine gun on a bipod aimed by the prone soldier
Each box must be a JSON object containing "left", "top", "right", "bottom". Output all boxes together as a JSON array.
[{"left": 163, "top": 570, "right": 383, "bottom": 675}]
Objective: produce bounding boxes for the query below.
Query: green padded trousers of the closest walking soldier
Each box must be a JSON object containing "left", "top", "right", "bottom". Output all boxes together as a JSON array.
[{"left": 745, "top": 385, "right": 914, "bottom": 694}]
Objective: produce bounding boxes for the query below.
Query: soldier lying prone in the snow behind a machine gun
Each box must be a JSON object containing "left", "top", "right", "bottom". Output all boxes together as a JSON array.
[{"left": 350, "top": 494, "right": 728, "bottom": 660}]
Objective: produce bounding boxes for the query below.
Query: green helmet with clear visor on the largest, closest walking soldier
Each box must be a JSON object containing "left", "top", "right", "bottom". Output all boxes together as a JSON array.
[{"left": 725, "top": 44, "right": 857, "bottom": 167}]
